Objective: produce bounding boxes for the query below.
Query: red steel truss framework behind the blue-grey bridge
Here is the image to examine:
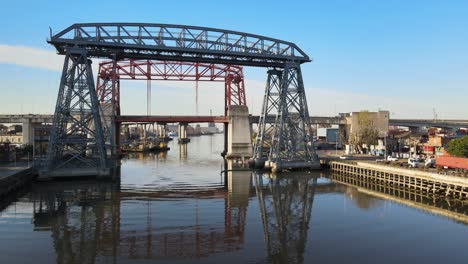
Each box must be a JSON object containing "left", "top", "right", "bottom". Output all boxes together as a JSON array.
[{"left": 96, "top": 59, "right": 246, "bottom": 115}]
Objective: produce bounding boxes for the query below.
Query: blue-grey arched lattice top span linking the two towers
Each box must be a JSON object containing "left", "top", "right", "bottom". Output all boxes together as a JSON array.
[{"left": 49, "top": 23, "right": 310, "bottom": 67}]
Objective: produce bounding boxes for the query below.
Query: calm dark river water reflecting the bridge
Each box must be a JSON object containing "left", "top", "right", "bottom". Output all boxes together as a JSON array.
[{"left": 0, "top": 135, "right": 468, "bottom": 263}]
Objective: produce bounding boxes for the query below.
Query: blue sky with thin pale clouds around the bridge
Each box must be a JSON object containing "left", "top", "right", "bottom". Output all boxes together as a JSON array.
[{"left": 0, "top": 0, "right": 468, "bottom": 119}]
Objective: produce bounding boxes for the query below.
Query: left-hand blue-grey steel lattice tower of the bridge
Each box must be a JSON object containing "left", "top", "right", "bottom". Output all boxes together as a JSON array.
[{"left": 40, "top": 49, "right": 108, "bottom": 177}]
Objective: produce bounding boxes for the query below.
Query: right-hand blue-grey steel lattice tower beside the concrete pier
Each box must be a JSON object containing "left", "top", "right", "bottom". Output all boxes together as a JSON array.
[{"left": 253, "top": 63, "right": 320, "bottom": 171}]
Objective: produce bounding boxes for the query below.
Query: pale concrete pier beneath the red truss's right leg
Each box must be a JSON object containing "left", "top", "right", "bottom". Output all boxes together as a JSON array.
[{"left": 224, "top": 105, "right": 252, "bottom": 159}]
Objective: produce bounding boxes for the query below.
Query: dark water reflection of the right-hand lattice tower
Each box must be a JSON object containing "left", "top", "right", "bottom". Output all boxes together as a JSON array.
[{"left": 254, "top": 174, "right": 317, "bottom": 263}]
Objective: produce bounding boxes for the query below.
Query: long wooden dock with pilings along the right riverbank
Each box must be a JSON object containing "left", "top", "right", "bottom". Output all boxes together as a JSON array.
[{"left": 329, "top": 161, "right": 468, "bottom": 199}]
